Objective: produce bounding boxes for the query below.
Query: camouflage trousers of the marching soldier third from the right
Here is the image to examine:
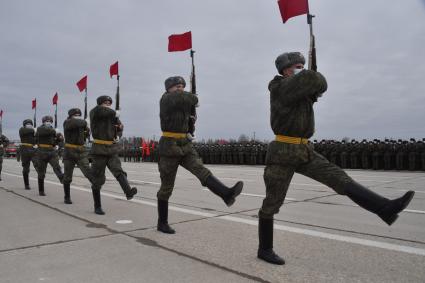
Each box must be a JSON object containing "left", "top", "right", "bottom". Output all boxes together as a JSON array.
[{"left": 90, "top": 153, "right": 127, "bottom": 190}]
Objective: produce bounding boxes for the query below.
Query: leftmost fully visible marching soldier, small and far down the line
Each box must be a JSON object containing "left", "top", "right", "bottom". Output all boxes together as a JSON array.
[{"left": 19, "top": 119, "right": 36, "bottom": 190}]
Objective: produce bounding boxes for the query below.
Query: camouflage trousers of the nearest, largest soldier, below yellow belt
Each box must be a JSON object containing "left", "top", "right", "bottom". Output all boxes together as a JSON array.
[{"left": 259, "top": 141, "right": 354, "bottom": 218}]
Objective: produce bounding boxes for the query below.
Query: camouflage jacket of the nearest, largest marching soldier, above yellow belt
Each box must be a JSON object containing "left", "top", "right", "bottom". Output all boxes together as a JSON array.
[{"left": 269, "top": 70, "right": 327, "bottom": 138}]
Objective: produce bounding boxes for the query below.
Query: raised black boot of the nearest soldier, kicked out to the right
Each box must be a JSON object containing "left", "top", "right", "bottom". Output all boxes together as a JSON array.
[{"left": 345, "top": 182, "right": 415, "bottom": 225}]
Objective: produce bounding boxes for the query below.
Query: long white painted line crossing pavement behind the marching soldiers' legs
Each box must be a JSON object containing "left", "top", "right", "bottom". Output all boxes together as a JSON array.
[{"left": 4, "top": 173, "right": 425, "bottom": 256}]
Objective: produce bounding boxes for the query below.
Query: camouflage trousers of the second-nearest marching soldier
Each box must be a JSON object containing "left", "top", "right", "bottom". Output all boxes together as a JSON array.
[{"left": 157, "top": 138, "right": 211, "bottom": 201}]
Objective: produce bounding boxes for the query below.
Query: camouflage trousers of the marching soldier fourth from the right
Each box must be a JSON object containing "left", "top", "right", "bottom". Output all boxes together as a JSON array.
[{"left": 63, "top": 148, "right": 93, "bottom": 184}]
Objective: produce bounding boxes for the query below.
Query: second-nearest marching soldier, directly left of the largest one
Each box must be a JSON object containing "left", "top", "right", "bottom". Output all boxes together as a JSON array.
[{"left": 157, "top": 77, "right": 243, "bottom": 234}]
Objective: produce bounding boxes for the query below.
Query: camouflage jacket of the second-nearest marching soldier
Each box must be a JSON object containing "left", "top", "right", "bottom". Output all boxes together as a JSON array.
[{"left": 159, "top": 91, "right": 198, "bottom": 133}]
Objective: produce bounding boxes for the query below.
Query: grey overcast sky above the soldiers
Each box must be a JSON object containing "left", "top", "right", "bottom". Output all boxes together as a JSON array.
[{"left": 0, "top": 0, "right": 425, "bottom": 140}]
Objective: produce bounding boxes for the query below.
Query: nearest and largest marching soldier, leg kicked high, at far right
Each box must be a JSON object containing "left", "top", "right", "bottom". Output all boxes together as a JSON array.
[{"left": 257, "top": 52, "right": 414, "bottom": 264}]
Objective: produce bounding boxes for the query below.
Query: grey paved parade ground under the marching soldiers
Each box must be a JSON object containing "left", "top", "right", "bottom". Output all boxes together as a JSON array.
[{"left": 0, "top": 159, "right": 425, "bottom": 283}]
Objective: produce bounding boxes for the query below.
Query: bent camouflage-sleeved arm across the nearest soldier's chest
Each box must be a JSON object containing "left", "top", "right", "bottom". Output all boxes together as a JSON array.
[{"left": 276, "top": 70, "right": 328, "bottom": 104}]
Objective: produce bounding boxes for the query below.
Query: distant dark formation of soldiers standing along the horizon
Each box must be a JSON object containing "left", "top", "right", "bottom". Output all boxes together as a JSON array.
[{"left": 117, "top": 138, "right": 425, "bottom": 171}]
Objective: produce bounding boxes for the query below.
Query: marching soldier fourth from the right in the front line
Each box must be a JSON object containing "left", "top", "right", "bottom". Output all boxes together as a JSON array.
[{"left": 63, "top": 108, "right": 93, "bottom": 204}]
